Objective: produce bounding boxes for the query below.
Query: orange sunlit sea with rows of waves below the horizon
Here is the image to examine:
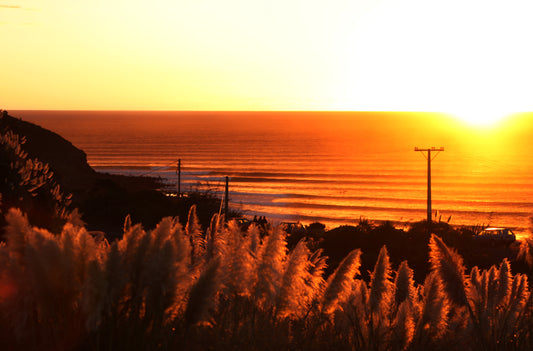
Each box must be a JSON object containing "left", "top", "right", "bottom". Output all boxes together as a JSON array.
[{"left": 10, "top": 111, "right": 533, "bottom": 238}]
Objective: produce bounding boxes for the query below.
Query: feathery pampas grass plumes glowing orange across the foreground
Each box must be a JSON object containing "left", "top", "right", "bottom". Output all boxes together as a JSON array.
[{"left": 0, "top": 206, "right": 533, "bottom": 351}]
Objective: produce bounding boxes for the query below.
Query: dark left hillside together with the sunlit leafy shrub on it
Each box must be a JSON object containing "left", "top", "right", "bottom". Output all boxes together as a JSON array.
[{"left": 0, "top": 111, "right": 224, "bottom": 239}]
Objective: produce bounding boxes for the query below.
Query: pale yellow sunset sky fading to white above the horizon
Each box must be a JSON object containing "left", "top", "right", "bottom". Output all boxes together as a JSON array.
[{"left": 0, "top": 0, "right": 533, "bottom": 118}]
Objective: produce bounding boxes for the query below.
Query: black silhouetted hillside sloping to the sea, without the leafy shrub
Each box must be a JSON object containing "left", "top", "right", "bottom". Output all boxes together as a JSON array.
[{"left": 0, "top": 111, "right": 219, "bottom": 237}]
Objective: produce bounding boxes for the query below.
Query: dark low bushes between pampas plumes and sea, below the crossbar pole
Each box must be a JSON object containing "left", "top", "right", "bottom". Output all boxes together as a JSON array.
[{"left": 288, "top": 220, "right": 528, "bottom": 282}]
